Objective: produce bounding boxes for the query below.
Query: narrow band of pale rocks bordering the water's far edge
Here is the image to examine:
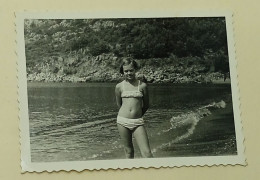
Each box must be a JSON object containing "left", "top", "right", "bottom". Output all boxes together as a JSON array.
[{"left": 27, "top": 70, "right": 230, "bottom": 83}]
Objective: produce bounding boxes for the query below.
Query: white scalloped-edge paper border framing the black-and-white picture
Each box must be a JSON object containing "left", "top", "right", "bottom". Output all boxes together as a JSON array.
[{"left": 15, "top": 11, "right": 246, "bottom": 172}]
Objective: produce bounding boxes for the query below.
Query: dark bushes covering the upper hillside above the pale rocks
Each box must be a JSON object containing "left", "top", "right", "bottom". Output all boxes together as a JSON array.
[{"left": 25, "top": 17, "right": 229, "bottom": 74}]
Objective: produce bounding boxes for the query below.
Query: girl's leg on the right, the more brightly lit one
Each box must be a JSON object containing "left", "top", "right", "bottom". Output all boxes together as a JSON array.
[{"left": 134, "top": 126, "right": 153, "bottom": 158}]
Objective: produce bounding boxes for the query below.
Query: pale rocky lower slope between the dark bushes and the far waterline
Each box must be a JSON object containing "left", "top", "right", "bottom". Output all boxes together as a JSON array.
[{"left": 27, "top": 53, "right": 229, "bottom": 83}]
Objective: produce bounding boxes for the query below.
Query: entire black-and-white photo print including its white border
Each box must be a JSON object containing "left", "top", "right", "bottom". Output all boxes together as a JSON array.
[{"left": 18, "top": 14, "right": 244, "bottom": 171}]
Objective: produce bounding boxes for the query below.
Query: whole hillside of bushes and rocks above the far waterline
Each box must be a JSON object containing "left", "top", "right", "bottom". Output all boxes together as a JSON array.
[{"left": 24, "top": 17, "right": 229, "bottom": 82}]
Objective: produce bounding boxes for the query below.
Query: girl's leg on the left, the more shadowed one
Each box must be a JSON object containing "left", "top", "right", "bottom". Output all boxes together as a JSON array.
[{"left": 117, "top": 124, "right": 134, "bottom": 159}]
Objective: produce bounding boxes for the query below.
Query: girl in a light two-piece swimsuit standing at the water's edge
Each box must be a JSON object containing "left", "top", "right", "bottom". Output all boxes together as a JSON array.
[{"left": 115, "top": 59, "right": 152, "bottom": 158}]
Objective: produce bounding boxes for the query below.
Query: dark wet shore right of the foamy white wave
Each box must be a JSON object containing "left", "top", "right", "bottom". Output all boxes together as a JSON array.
[{"left": 162, "top": 99, "right": 237, "bottom": 157}]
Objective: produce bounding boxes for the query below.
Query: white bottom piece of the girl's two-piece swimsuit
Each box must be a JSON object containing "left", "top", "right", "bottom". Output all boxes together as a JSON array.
[{"left": 117, "top": 116, "right": 144, "bottom": 130}]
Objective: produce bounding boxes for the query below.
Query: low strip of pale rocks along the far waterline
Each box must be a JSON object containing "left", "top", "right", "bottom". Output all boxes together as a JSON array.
[{"left": 27, "top": 67, "right": 230, "bottom": 84}]
